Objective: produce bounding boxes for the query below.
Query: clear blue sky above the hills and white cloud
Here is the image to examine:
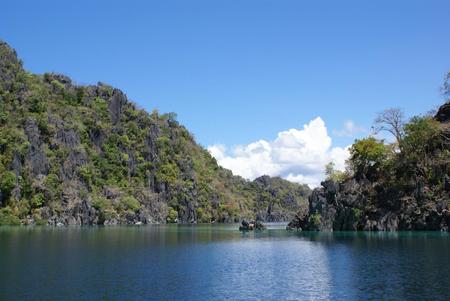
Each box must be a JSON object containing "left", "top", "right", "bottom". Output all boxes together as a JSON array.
[{"left": 0, "top": 0, "right": 450, "bottom": 185}]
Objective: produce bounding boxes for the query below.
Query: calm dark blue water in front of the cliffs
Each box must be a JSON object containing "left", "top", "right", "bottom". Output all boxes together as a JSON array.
[{"left": 0, "top": 225, "right": 450, "bottom": 300}]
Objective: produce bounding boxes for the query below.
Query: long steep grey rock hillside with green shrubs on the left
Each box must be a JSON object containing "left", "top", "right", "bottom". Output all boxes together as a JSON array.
[{"left": 0, "top": 42, "right": 309, "bottom": 225}]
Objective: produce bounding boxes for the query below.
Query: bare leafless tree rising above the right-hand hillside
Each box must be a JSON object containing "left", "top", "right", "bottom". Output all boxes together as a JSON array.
[{"left": 373, "top": 108, "right": 405, "bottom": 144}]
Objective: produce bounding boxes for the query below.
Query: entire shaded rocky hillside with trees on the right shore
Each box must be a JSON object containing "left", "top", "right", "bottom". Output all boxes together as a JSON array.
[{"left": 288, "top": 98, "right": 450, "bottom": 231}]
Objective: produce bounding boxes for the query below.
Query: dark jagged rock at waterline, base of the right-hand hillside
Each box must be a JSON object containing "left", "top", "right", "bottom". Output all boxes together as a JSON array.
[{"left": 288, "top": 180, "right": 450, "bottom": 231}]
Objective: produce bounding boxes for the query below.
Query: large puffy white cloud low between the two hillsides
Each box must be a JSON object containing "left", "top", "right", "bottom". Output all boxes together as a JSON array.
[{"left": 208, "top": 117, "right": 349, "bottom": 187}]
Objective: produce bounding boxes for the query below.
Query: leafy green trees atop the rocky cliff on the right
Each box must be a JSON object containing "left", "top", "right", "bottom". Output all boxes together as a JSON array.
[{"left": 348, "top": 110, "right": 450, "bottom": 191}]
